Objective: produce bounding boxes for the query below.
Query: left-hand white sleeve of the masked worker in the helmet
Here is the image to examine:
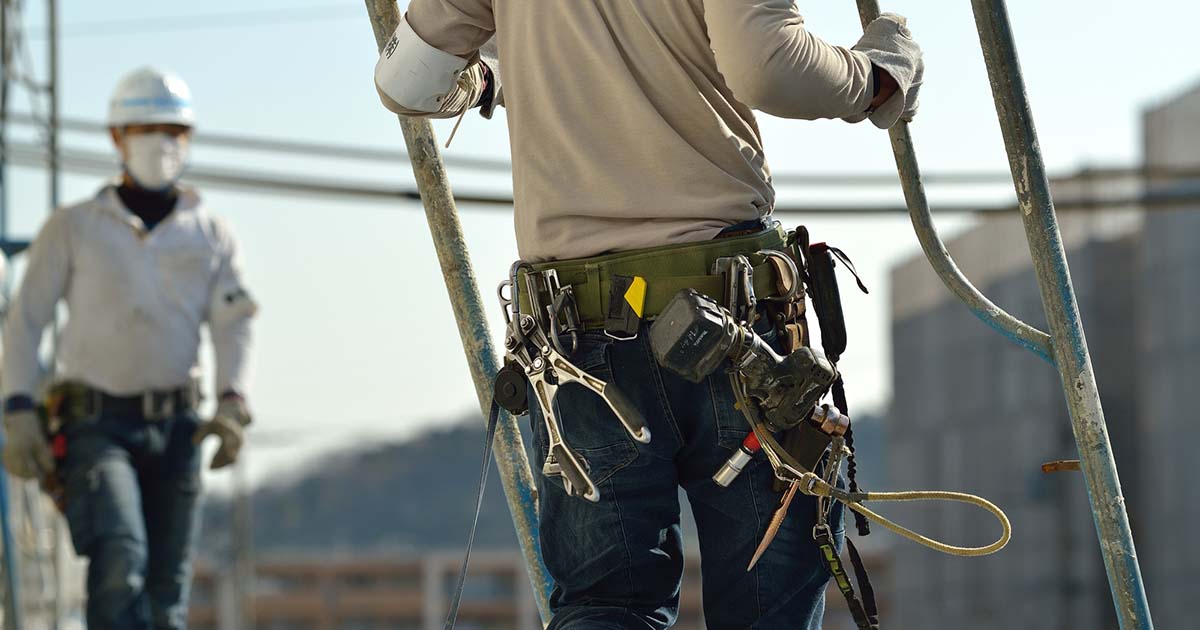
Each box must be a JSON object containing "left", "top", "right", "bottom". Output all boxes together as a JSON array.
[{"left": 4, "top": 210, "right": 71, "bottom": 400}]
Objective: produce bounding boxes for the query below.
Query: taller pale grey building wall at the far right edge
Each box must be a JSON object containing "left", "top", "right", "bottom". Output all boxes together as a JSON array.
[{"left": 1134, "top": 84, "right": 1200, "bottom": 628}]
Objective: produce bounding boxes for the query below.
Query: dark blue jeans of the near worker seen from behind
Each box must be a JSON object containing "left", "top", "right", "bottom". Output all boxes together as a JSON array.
[{"left": 530, "top": 325, "right": 842, "bottom": 630}]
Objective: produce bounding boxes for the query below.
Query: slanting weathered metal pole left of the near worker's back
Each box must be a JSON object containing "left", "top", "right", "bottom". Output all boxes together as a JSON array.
[{"left": 357, "top": 0, "right": 551, "bottom": 620}]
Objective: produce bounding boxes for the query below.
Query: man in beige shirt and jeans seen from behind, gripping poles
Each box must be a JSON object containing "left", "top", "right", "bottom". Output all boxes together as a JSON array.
[{"left": 374, "top": 0, "right": 923, "bottom": 629}]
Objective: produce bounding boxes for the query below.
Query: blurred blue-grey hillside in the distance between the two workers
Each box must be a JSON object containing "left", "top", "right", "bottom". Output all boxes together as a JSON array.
[{"left": 202, "top": 415, "right": 887, "bottom": 554}]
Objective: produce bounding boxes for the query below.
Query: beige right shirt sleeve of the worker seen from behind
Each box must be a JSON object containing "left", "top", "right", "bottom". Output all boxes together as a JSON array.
[{"left": 704, "top": 0, "right": 874, "bottom": 120}]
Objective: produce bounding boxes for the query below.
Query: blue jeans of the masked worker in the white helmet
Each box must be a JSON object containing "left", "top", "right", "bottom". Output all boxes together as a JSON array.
[{"left": 62, "top": 412, "right": 200, "bottom": 630}]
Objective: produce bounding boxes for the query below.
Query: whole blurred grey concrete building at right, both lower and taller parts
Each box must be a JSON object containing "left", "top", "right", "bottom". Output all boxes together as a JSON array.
[{"left": 889, "top": 81, "right": 1200, "bottom": 630}]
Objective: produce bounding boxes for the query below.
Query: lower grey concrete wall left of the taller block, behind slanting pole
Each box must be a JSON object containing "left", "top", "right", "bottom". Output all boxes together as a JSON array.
[{"left": 888, "top": 212, "right": 1139, "bottom": 630}]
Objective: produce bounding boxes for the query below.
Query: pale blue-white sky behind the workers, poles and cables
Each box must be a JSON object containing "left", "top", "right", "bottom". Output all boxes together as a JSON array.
[{"left": 8, "top": 0, "right": 1200, "bottom": 486}]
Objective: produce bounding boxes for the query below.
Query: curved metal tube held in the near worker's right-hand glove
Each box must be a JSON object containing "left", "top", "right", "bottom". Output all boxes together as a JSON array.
[{"left": 858, "top": 0, "right": 1054, "bottom": 364}]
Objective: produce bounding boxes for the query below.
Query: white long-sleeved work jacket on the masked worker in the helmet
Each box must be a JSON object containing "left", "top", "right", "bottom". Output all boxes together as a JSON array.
[{"left": 2, "top": 184, "right": 256, "bottom": 398}]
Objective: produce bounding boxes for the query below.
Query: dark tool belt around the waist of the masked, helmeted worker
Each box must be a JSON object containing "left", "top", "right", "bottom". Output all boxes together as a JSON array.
[{"left": 46, "top": 380, "right": 200, "bottom": 422}]
